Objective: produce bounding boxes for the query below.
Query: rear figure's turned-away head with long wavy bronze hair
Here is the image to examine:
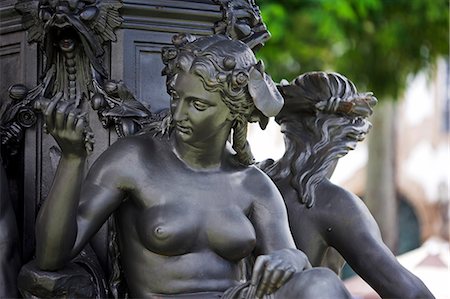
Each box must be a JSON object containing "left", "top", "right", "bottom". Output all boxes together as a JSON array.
[{"left": 266, "top": 72, "right": 377, "bottom": 207}]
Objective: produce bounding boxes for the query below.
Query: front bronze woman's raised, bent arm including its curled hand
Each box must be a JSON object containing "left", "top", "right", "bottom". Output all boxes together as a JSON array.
[{"left": 36, "top": 98, "right": 123, "bottom": 270}]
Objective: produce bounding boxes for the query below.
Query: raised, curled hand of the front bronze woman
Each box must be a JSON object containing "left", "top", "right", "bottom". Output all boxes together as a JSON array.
[{"left": 35, "top": 93, "right": 94, "bottom": 157}]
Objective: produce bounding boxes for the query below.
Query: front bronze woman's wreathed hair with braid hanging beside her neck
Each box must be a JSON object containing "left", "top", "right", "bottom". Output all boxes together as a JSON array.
[{"left": 162, "top": 35, "right": 283, "bottom": 165}]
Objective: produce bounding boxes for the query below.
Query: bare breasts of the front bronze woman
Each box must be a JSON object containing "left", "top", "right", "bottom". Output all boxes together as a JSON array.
[{"left": 135, "top": 201, "right": 256, "bottom": 261}]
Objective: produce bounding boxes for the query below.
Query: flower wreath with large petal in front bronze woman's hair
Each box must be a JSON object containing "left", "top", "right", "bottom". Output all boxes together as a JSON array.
[{"left": 161, "top": 34, "right": 284, "bottom": 129}]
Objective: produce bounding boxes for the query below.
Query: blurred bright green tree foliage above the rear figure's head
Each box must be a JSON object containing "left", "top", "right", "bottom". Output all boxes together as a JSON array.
[{"left": 257, "top": 0, "right": 449, "bottom": 99}]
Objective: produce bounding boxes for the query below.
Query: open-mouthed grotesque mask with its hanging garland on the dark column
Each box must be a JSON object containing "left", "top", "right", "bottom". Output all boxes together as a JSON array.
[{"left": 1, "top": 0, "right": 151, "bottom": 155}]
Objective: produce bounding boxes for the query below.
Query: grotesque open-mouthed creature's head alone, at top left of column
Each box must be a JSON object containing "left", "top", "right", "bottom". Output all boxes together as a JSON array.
[{"left": 15, "top": 0, "right": 123, "bottom": 77}]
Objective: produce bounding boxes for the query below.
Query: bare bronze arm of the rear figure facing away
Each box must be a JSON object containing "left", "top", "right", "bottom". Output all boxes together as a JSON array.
[{"left": 314, "top": 182, "right": 434, "bottom": 298}]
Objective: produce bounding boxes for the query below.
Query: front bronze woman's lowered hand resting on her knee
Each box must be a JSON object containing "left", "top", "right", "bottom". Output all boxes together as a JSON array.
[{"left": 251, "top": 249, "right": 311, "bottom": 298}]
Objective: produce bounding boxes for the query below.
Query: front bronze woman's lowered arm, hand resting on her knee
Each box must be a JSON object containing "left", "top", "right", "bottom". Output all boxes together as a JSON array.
[{"left": 250, "top": 171, "right": 311, "bottom": 298}]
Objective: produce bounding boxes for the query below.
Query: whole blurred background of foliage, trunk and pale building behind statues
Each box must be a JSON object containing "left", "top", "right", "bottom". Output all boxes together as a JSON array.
[{"left": 249, "top": 0, "right": 450, "bottom": 298}]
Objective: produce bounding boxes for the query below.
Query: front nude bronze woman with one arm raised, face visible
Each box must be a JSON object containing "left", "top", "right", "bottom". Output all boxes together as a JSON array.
[{"left": 36, "top": 36, "right": 349, "bottom": 298}]
